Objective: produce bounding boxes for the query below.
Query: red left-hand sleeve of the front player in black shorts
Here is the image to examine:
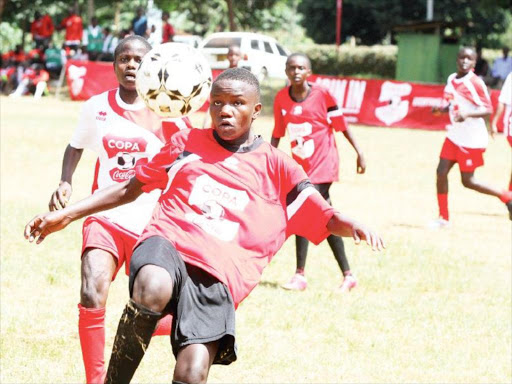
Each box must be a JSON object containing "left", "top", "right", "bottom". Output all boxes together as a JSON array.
[{"left": 135, "top": 130, "right": 185, "bottom": 192}]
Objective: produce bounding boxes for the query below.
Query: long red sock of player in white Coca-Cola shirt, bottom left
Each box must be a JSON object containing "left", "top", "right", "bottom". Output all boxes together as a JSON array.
[{"left": 78, "top": 304, "right": 106, "bottom": 384}]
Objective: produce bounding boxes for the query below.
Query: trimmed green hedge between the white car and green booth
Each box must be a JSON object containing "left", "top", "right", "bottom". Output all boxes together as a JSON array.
[{"left": 298, "top": 45, "right": 398, "bottom": 79}]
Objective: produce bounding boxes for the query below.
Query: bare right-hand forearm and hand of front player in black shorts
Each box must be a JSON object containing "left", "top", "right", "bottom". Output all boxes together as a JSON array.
[{"left": 327, "top": 212, "right": 385, "bottom": 251}]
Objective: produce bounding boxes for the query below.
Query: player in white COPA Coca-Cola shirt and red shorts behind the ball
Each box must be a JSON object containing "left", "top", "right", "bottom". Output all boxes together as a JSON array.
[{"left": 49, "top": 36, "right": 190, "bottom": 383}]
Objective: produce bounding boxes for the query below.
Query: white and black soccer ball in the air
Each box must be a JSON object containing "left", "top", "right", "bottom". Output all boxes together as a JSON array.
[{"left": 135, "top": 43, "right": 212, "bottom": 117}]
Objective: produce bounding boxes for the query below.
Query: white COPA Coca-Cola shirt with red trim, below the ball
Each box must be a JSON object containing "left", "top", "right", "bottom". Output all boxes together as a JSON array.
[{"left": 70, "top": 89, "right": 190, "bottom": 235}]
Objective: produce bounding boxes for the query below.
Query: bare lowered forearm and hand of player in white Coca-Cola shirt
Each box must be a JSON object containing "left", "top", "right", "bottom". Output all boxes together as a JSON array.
[{"left": 48, "top": 144, "right": 84, "bottom": 211}]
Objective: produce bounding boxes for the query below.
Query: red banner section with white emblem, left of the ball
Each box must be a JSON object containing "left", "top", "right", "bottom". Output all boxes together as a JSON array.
[{"left": 66, "top": 60, "right": 119, "bottom": 100}]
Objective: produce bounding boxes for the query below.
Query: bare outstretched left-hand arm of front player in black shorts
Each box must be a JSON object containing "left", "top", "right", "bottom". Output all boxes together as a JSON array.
[{"left": 24, "top": 177, "right": 143, "bottom": 244}]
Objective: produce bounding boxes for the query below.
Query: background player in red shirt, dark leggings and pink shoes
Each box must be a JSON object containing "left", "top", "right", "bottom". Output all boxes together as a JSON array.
[{"left": 271, "top": 53, "right": 366, "bottom": 292}]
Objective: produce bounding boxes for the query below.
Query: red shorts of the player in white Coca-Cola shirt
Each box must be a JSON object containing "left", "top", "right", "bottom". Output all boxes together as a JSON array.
[{"left": 82, "top": 216, "right": 139, "bottom": 280}]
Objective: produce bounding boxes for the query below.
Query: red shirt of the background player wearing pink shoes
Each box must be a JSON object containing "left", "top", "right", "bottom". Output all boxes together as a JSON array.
[{"left": 272, "top": 84, "right": 347, "bottom": 184}]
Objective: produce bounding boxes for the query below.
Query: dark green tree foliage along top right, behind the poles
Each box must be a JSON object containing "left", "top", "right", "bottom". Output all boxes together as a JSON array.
[{"left": 298, "top": 0, "right": 510, "bottom": 47}]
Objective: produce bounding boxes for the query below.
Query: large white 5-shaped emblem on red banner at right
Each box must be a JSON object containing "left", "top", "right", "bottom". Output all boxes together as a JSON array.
[{"left": 375, "top": 81, "right": 412, "bottom": 125}]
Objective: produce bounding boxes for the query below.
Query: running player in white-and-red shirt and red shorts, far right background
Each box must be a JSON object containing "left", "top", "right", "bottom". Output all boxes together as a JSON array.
[{"left": 429, "top": 47, "right": 512, "bottom": 228}]
